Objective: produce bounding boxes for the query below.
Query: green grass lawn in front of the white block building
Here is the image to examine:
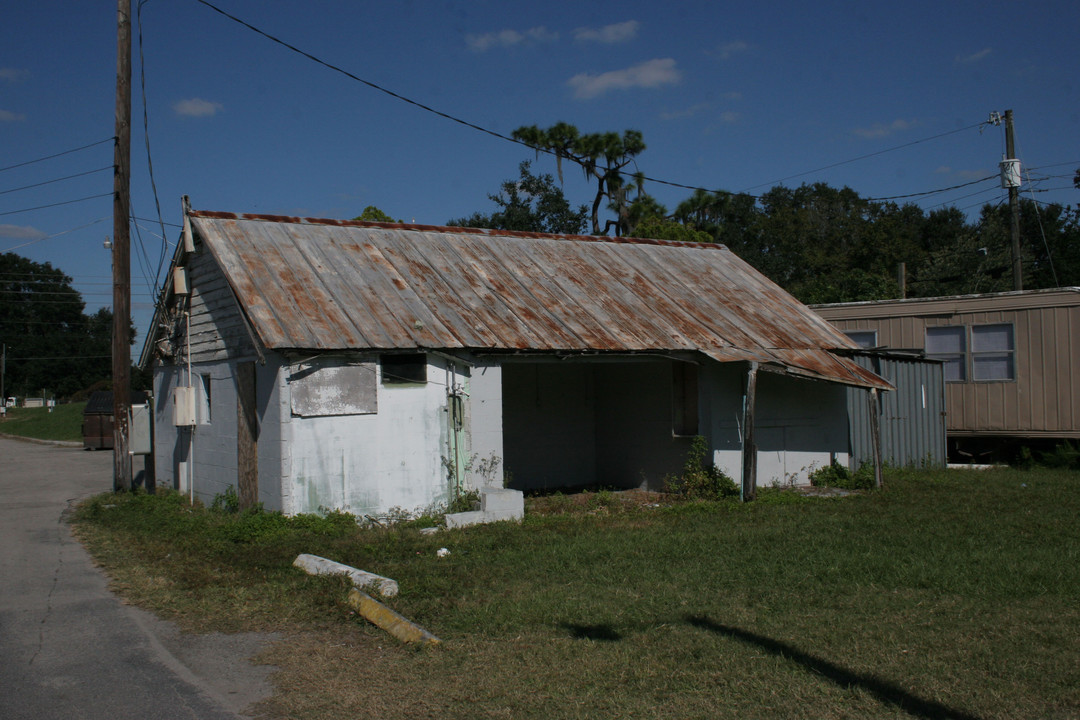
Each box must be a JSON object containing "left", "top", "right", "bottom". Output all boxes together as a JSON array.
[{"left": 76, "top": 470, "right": 1080, "bottom": 719}]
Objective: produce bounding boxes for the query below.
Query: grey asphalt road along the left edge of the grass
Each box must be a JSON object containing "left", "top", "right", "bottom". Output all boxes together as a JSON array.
[{"left": 0, "top": 437, "right": 272, "bottom": 720}]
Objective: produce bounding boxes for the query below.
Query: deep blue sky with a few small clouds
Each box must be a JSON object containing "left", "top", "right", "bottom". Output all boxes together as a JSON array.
[{"left": 0, "top": 0, "right": 1080, "bottom": 343}]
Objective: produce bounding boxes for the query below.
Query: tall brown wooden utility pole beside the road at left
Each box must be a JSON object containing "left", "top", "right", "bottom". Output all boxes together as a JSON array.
[{"left": 112, "top": 0, "right": 132, "bottom": 492}]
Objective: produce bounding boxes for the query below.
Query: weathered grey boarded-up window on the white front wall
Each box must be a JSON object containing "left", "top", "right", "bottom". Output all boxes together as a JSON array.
[{"left": 288, "top": 358, "right": 378, "bottom": 418}]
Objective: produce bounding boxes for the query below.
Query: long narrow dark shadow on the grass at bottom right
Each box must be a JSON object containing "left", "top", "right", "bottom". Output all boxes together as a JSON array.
[{"left": 686, "top": 615, "right": 978, "bottom": 720}]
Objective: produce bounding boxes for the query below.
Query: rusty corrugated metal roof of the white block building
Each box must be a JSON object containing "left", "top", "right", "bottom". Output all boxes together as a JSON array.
[{"left": 189, "top": 212, "right": 889, "bottom": 388}]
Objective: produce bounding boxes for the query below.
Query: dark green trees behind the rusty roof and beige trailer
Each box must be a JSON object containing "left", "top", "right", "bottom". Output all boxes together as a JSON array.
[{"left": 448, "top": 123, "right": 1080, "bottom": 303}]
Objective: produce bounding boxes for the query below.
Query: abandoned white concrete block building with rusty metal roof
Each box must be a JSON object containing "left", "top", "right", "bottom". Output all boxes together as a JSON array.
[{"left": 141, "top": 208, "right": 890, "bottom": 517}]
